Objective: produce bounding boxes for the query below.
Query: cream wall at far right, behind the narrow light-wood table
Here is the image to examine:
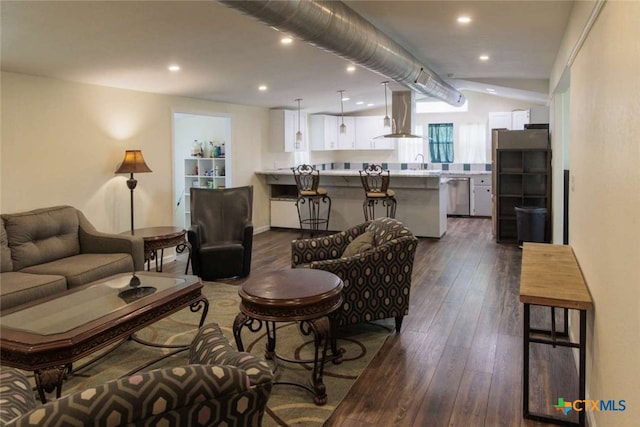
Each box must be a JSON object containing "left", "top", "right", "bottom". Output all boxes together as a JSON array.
[{"left": 554, "top": 1, "right": 640, "bottom": 427}]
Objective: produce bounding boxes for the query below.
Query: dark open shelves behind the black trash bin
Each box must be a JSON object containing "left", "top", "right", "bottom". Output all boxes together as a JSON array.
[{"left": 496, "top": 149, "right": 551, "bottom": 242}]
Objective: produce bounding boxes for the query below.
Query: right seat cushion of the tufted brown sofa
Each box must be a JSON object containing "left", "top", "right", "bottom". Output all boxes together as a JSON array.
[{"left": 21, "top": 253, "right": 133, "bottom": 289}]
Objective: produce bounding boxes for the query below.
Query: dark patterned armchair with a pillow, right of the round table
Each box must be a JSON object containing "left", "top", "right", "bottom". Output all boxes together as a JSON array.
[{"left": 291, "top": 218, "right": 418, "bottom": 332}]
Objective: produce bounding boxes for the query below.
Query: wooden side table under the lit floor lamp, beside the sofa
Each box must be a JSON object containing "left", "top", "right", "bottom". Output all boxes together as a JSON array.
[{"left": 121, "top": 226, "right": 191, "bottom": 274}]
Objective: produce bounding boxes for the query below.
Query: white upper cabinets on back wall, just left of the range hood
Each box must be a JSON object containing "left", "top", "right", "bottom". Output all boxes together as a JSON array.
[{"left": 309, "top": 114, "right": 395, "bottom": 151}]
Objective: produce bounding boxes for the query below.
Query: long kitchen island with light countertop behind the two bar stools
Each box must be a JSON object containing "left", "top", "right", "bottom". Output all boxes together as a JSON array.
[{"left": 256, "top": 169, "right": 448, "bottom": 238}]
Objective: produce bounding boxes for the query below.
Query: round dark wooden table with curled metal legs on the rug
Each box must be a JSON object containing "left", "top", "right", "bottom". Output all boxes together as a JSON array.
[{"left": 233, "top": 268, "right": 344, "bottom": 405}]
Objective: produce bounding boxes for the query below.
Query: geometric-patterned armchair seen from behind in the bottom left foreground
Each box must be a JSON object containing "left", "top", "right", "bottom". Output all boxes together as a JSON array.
[{"left": 0, "top": 324, "right": 273, "bottom": 427}]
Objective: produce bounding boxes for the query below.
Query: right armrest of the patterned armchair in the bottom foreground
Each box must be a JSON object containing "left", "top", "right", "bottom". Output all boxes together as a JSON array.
[{"left": 189, "top": 323, "right": 273, "bottom": 390}]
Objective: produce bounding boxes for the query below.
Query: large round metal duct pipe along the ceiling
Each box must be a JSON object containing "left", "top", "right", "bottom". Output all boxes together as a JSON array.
[{"left": 219, "top": 0, "right": 465, "bottom": 106}]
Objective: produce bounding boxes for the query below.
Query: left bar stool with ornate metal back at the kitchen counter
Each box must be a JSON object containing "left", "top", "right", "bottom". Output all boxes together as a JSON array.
[{"left": 291, "top": 164, "right": 331, "bottom": 237}]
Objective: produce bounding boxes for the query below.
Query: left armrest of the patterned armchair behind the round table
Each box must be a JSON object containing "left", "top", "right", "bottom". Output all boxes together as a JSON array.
[{"left": 291, "top": 222, "right": 369, "bottom": 267}]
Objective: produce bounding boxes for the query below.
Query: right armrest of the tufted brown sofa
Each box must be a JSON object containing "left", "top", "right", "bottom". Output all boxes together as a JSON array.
[{"left": 76, "top": 210, "right": 144, "bottom": 271}]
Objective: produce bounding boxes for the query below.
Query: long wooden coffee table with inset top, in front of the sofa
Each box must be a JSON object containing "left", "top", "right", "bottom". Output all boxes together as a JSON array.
[{"left": 0, "top": 272, "right": 209, "bottom": 403}]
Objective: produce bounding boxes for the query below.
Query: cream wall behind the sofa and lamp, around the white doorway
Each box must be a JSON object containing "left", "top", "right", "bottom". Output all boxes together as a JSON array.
[{"left": 0, "top": 73, "right": 269, "bottom": 232}]
